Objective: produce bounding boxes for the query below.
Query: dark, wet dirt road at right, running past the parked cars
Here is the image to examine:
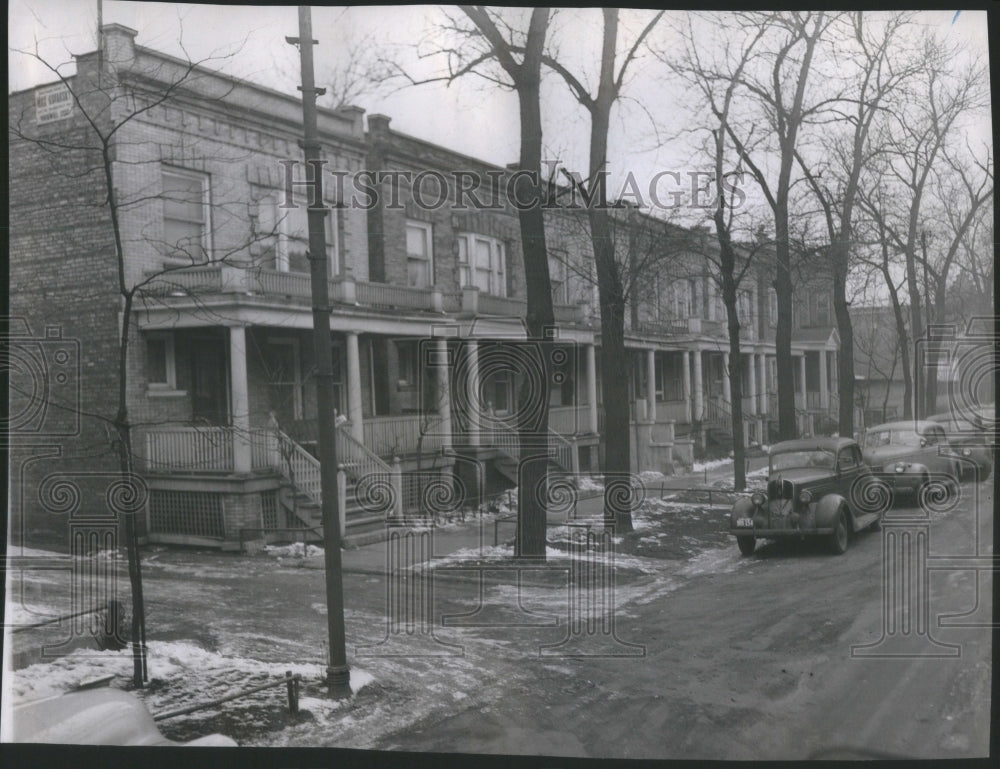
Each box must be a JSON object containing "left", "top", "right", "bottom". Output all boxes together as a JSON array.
[{"left": 380, "top": 483, "right": 992, "bottom": 759}]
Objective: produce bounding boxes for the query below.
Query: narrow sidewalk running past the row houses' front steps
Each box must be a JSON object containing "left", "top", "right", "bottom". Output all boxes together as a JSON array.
[{"left": 332, "top": 456, "right": 767, "bottom": 575}]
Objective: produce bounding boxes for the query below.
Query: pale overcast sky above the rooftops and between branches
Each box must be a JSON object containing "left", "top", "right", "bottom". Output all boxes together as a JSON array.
[{"left": 8, "top": 0, "right": 991, "bottom": 231}]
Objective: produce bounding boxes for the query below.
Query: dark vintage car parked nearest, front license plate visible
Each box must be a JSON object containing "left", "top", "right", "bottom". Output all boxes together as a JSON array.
[{"left": 729, "top": 438, "right": 890, "bottom": 555}]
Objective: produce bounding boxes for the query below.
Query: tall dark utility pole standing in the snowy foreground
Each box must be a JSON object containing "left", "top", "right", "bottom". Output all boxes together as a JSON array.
[{"left": 285, "top": 5, "right": 351, "bottom": 699}]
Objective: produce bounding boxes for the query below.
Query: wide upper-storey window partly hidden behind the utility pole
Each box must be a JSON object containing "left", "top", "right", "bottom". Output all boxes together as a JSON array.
[{"left": 255, "top": 190, "right": 340, "bottom": 277}]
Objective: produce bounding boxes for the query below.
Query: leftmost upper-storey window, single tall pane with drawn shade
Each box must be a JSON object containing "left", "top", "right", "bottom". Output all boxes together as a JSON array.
[{"left": 162, "top": 168, "right": 209, "bottom": 262}]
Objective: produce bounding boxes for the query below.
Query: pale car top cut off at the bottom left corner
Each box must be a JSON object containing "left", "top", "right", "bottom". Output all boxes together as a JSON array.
[{"left": 5, "top": 688, "right": 236, "bottom": 747}]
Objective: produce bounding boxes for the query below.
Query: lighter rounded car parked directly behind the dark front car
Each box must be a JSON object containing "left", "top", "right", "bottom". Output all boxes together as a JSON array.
[{"left": 863, "top": 419, "right": 961, "bottom": 495}]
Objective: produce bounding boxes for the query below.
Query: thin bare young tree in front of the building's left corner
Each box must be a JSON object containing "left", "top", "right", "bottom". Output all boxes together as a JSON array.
[{"left": 9, "top": 30, "right": 258, "bottom": 687}]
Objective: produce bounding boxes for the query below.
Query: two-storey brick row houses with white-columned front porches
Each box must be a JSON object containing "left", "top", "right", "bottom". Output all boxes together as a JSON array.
[{"left": 10, "top": 25, "right": 836, "bottom": 547}]
